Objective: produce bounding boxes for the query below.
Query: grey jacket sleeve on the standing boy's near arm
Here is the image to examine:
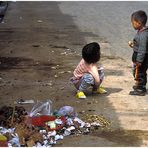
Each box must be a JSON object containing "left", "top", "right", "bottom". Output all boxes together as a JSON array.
[{"left": 136, "top": 33, "right": 148, "bottom": 63}]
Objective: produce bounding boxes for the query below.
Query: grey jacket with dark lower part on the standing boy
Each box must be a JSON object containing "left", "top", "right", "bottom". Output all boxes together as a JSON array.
[{"left": 132, "top": 27, "right": 148, "bottom": 67}]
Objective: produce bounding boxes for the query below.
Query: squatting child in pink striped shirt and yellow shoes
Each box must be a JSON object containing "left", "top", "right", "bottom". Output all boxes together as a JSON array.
[{"left": 71, "top": 42, "right": 106, "bottom": 98}]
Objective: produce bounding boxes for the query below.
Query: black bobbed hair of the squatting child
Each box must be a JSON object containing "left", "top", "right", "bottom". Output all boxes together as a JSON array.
[{"left": 82, "top": 42, "right": 101, "bottom": 64}]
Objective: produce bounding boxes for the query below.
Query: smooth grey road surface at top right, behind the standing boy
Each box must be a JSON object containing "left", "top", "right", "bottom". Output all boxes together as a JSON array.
[{"left": 59, "top": 1, "right": 148, "bottom": 59}]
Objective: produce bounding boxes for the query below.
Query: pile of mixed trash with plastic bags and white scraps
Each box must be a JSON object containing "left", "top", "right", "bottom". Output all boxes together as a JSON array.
[{"left": 0, "top": 100, "right": 109, "bottom": 147}]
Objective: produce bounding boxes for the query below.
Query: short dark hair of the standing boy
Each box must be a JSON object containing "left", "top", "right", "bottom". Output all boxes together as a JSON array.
[{"left": 131, "top": 10, "right": 147, "bottom": 26}]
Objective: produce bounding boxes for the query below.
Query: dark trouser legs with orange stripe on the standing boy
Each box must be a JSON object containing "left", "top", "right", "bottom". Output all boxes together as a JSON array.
[{"left": 133, "top": 64, "right": 148, "bottom": 91}]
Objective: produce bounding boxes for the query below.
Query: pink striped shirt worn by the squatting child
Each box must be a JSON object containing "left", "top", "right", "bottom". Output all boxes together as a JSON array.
[{"left": 73, "top": 59, "right": 100, "bottom": 84}]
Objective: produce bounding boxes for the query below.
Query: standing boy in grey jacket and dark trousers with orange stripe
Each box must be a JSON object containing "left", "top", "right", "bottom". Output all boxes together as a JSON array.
[{"left": 129, "top": 10, "right": 148, "bottom": 96}]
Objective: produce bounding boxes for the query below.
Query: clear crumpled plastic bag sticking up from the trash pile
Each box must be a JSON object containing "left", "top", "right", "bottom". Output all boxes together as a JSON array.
[{"left": 29, "top": 100, "right": 52, "bottom": 117}]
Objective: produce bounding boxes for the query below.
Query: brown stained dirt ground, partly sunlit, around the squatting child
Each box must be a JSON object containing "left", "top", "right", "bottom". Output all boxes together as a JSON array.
[{"left": 0, "top": 2, "right": 148, "bottom": 147}]
